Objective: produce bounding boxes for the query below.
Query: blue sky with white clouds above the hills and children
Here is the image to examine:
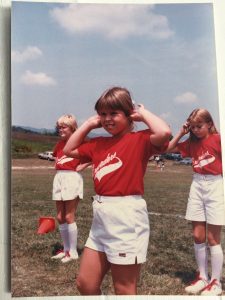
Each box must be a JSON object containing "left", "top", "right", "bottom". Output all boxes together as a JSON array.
[{"left": 11, "top": 2, "right": 220, "bottom": 133}]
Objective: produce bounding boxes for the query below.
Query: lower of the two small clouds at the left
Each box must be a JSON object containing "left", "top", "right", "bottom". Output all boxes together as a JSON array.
[{"left": 21, "top": 70, "right": 56, "bottom": 86}]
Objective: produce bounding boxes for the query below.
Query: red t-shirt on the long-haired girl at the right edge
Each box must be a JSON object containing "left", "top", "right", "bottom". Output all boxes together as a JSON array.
[{"left": 178, "top": 134, "right": 222, "bottom": 175}]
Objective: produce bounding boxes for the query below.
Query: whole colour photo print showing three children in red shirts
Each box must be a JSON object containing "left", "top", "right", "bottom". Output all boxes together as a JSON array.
[{"left": 11, "top": 1, "right": 225, "bottom": 297}]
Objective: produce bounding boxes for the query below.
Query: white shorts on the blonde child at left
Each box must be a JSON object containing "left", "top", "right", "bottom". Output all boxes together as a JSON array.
[{"left": 52, "top": 170, "right": 83, "bottom": 201}]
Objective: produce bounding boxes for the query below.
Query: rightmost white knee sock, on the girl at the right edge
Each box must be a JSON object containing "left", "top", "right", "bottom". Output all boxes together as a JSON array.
[{"left": 209, "top": 244, "right": 223, "bottom": 282}]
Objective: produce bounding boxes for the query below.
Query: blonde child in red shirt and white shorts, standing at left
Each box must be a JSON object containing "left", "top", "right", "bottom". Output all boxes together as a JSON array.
[{"left": 52, "top": 114, "right": 89, "bottom": 263}]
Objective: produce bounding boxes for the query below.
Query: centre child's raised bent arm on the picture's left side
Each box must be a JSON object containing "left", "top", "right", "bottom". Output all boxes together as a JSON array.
[{"left": 63, "top": 115, "right": 101, "bottom": 158}]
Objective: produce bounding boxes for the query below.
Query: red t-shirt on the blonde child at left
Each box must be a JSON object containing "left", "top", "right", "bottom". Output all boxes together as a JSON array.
[{"left": 53, "top": 140, "right": 80, "bottom": 171}]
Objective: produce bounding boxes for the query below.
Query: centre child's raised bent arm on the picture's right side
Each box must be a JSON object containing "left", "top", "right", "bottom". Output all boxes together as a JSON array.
[{"left": 131, "top": 104, "right": 171, "bottom": 146}]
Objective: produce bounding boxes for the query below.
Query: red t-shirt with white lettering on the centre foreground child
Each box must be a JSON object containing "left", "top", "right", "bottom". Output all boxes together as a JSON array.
[{"left": 78, "top": 130, "right": 167, "bottom": 196}]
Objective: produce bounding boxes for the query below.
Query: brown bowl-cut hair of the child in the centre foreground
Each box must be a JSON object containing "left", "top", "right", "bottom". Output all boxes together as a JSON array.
[{"left": 95, "top": 87, "right": 134, "bottom": 117}]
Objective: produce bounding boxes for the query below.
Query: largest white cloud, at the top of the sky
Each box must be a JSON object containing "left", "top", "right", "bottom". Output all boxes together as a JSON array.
[{"left": 50, "top": 4, "right": 174, "bottom": 39}]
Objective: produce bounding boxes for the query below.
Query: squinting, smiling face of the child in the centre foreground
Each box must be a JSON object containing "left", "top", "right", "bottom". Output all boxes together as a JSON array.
[{"left": 98, "top": 109, "right": 131, "bottom": 137}]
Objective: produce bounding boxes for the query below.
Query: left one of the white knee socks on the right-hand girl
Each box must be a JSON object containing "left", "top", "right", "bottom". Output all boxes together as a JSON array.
[{"left": 194, "top": 243, "right": 208, "bottom": 280}]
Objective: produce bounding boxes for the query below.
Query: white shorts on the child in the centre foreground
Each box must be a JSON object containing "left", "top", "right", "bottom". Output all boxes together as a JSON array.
[{"left": 85, "top": 196, "right": 150, "bottom": 265}]
